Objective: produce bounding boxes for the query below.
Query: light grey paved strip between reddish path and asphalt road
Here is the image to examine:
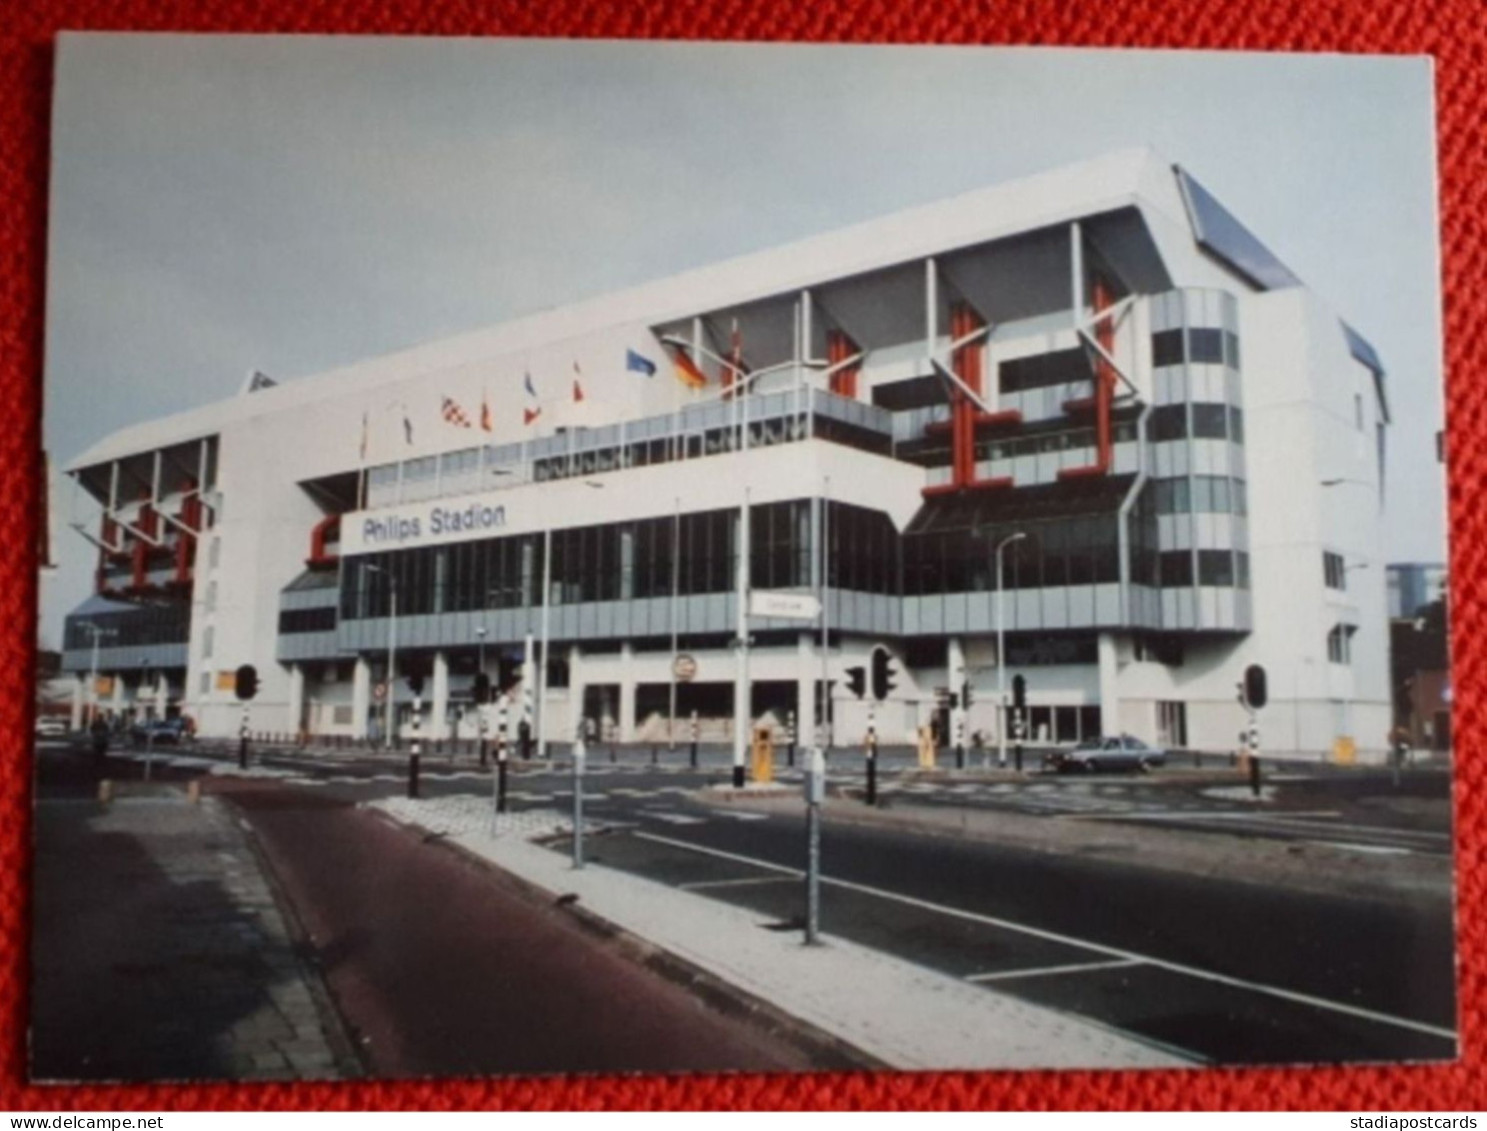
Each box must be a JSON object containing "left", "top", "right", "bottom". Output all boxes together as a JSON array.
[{"left": 373, "top": 797, "right": 1190, "bottom": 1070}]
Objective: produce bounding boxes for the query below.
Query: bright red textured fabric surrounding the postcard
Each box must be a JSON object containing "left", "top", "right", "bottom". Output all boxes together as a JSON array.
[{"left": 0, "top": 0, "right": 1487, "bottom": 1112}]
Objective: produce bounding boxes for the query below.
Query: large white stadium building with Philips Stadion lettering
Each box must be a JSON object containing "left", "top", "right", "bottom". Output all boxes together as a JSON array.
[{"left": 62, "top": 150, "right": 1390, "bottom": 756}]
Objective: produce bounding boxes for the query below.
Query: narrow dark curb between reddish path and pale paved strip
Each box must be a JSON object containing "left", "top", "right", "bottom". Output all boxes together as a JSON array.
[{"left": 364, "top": 807, "right": 892, "bottom": 1072}]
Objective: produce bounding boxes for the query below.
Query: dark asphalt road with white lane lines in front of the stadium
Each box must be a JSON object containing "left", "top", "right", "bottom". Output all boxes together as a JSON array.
[{"left": 86, "top": 740, "right": 1456, "bottom": 1063}]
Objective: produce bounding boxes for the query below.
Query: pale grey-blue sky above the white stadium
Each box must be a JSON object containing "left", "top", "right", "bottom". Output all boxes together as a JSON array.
[{"left": 42, "top": 34, "right": 1445, "bottom": 642}]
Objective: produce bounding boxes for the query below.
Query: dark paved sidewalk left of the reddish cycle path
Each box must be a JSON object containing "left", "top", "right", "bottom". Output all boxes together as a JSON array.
[{"left": 30, "top": 783, "right": 358, "bottom": 1082}]
